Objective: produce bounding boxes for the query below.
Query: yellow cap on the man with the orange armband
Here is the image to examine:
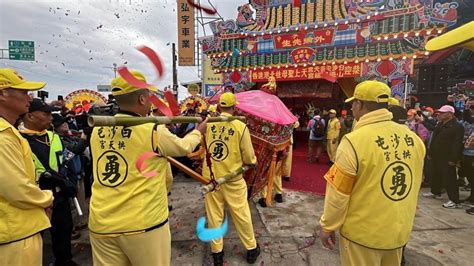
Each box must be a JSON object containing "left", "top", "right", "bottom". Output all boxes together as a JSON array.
[{"left": 346, "top": 80, "right": 392, "bottom": 103}]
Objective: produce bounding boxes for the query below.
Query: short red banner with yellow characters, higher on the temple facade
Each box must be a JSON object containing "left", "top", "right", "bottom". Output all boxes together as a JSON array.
[{"left": 273, "top": 29, "right": 334, "bottom": 49}]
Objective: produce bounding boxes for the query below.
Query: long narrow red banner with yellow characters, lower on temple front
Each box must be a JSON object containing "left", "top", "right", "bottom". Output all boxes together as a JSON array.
[{"left": 249, "top": 63, "right": 362, "bottom": 82}]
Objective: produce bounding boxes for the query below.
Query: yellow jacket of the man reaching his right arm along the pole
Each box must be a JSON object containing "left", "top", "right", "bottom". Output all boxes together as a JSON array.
[{"left": 89, "top": 114, "right": 201, "bottom": 236}]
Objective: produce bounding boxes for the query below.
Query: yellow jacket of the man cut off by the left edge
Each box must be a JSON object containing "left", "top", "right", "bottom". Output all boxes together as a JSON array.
[{"left": 0, "top": 118, "right": 53, "bottom": 244}]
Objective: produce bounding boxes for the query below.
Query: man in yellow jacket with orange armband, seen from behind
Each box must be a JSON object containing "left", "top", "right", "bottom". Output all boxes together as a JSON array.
[{"left": 320, "top": 81, "right": 425, "bottom": 265}]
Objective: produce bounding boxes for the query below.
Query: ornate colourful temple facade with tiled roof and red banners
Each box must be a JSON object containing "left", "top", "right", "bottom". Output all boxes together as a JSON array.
[{"left": 201, "top": 0, "right": 472, "bottom": 113}]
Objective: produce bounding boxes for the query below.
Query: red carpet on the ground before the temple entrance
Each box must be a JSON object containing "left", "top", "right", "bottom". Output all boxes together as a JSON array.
[{"left": 282, "top": 142, "right": 329, "bottom": 195}]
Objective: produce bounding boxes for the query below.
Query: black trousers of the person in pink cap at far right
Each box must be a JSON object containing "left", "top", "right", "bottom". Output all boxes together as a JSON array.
[{"left": 431, "top": 157, "right": 460, "bottom": 203}]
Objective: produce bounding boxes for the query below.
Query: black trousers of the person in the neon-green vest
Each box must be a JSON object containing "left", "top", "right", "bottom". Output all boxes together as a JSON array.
[{"left": 50, "top": 195, "right": 73, "bottom": 266}]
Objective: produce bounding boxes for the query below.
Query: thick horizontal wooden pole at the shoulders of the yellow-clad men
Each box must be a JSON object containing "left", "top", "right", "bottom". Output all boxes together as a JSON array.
[{"left": 87, "top": 115, "right": 246, "bottom": 127}]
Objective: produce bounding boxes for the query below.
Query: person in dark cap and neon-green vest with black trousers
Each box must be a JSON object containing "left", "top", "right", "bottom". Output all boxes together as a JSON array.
[{"left": 19, "top": 99, "right": 77, "bottom": 265}]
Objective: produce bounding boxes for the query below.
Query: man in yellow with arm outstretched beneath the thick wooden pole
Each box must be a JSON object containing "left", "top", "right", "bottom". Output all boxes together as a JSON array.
[{"left": 89, "top": 71, "right": 206, "bottom": 266}]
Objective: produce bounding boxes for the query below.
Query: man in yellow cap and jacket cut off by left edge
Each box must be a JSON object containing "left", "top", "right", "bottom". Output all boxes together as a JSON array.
[{"left": 0, "top": 68, "right": 53, "bottom": 266}]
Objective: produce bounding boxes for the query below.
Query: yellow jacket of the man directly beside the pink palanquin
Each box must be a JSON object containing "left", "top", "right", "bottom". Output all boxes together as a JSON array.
[{"left": 202, "top": 113, "right": 257, "bottom": 180}]
